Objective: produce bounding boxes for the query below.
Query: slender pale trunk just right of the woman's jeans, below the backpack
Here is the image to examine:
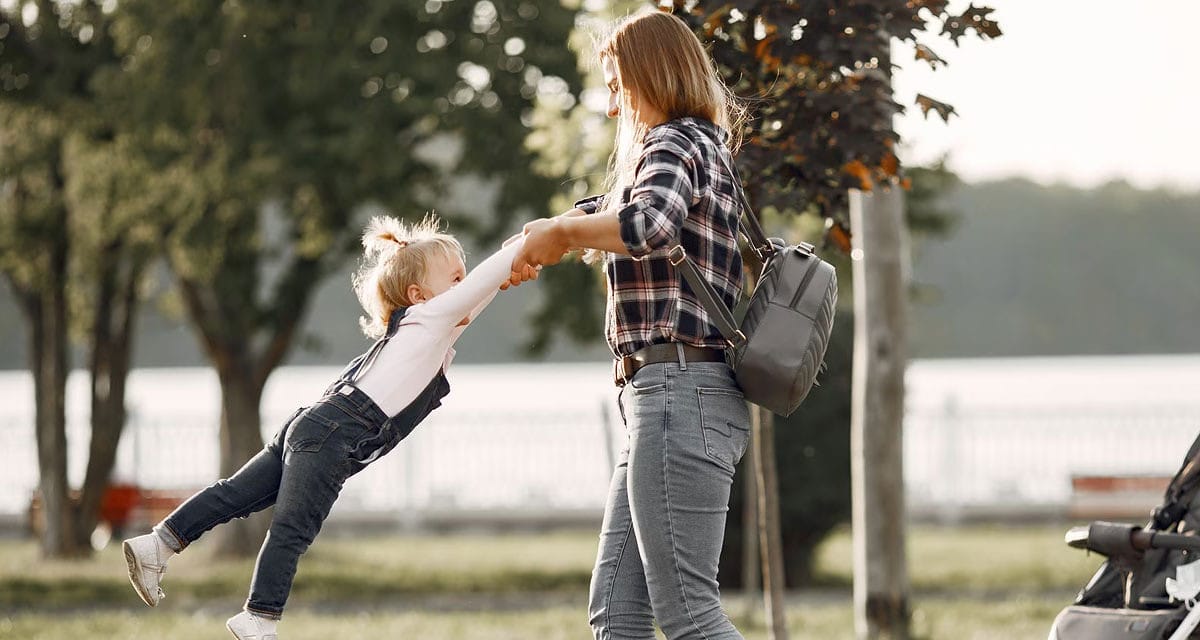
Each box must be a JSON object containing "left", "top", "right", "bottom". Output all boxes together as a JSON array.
[{"left": 750, "top": 407, "right": 787, "bottom": 640}]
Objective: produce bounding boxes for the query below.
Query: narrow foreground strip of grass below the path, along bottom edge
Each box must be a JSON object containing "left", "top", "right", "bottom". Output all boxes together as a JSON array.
[{"left": 0, "top": 593, "right": 1064, "bottom": 640}]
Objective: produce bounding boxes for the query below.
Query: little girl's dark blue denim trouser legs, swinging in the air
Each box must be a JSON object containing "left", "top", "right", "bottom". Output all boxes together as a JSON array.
[{"left": 155, "top": 385, "right": 400, "bottom": 618}]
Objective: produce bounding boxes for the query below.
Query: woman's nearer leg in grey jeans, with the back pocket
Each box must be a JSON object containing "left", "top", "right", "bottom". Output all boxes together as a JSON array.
[{"left": 628, "top": 364, "right": 749, "bottom": 640}]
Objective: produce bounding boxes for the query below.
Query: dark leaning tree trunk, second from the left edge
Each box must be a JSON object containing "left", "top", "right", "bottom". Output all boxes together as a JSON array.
[{"left": 77, "top": 241, "right": 148, "bottom": 545}]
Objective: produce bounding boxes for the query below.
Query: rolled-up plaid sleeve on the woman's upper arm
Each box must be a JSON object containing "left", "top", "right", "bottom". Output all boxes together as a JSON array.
[{"left": 617, "top": 139, "right": 695, "bottom": 257}]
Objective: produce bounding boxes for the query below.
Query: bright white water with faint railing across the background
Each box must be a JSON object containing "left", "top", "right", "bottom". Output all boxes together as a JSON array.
[{"left": 0, "top": 357, "right": 1200, "bottom": 525}]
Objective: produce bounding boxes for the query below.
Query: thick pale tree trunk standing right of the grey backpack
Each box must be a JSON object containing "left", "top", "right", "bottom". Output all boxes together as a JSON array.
[{"left": 850, "top": 187, "right": 910, "bottom": 640}]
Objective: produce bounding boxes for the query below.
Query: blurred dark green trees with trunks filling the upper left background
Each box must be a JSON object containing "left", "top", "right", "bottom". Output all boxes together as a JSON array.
[{"left": 0, "top": 0, "right": 590, "bottom": 555}]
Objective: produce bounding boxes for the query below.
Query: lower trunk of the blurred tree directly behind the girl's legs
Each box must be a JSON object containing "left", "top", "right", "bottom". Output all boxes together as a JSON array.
[{"left": 212, "top": 366, "right": 270, "bottom": 557}]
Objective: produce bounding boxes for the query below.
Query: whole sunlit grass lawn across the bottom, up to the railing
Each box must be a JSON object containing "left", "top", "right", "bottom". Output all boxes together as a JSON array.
[{"left": 0, "top": 526, "right": 1098, "bottom": 640}]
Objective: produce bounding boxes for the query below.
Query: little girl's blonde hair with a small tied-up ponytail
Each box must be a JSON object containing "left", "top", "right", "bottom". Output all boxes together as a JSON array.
[{"left": 354, "top": 214, "right": 463, "bottom": 339}]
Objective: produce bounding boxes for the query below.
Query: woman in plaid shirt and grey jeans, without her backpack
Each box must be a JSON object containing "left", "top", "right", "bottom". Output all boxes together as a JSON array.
[{"left": 512, "top": 12, "right": 749, "bottom": 640}]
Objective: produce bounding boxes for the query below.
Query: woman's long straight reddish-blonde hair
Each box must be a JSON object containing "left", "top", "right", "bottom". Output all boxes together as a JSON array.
[{"left": 599, "top": 11, "right": 746, "bottom": 208}]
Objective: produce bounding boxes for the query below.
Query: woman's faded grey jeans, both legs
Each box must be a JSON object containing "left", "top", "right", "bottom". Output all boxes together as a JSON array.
[{"left": 588, "top": 363, "right": 750, "bottom": 640}]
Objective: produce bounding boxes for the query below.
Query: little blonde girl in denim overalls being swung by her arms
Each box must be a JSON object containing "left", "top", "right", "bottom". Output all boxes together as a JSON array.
[{"left": 124, "top": 216, "right": 536, "bottom": 640}]
